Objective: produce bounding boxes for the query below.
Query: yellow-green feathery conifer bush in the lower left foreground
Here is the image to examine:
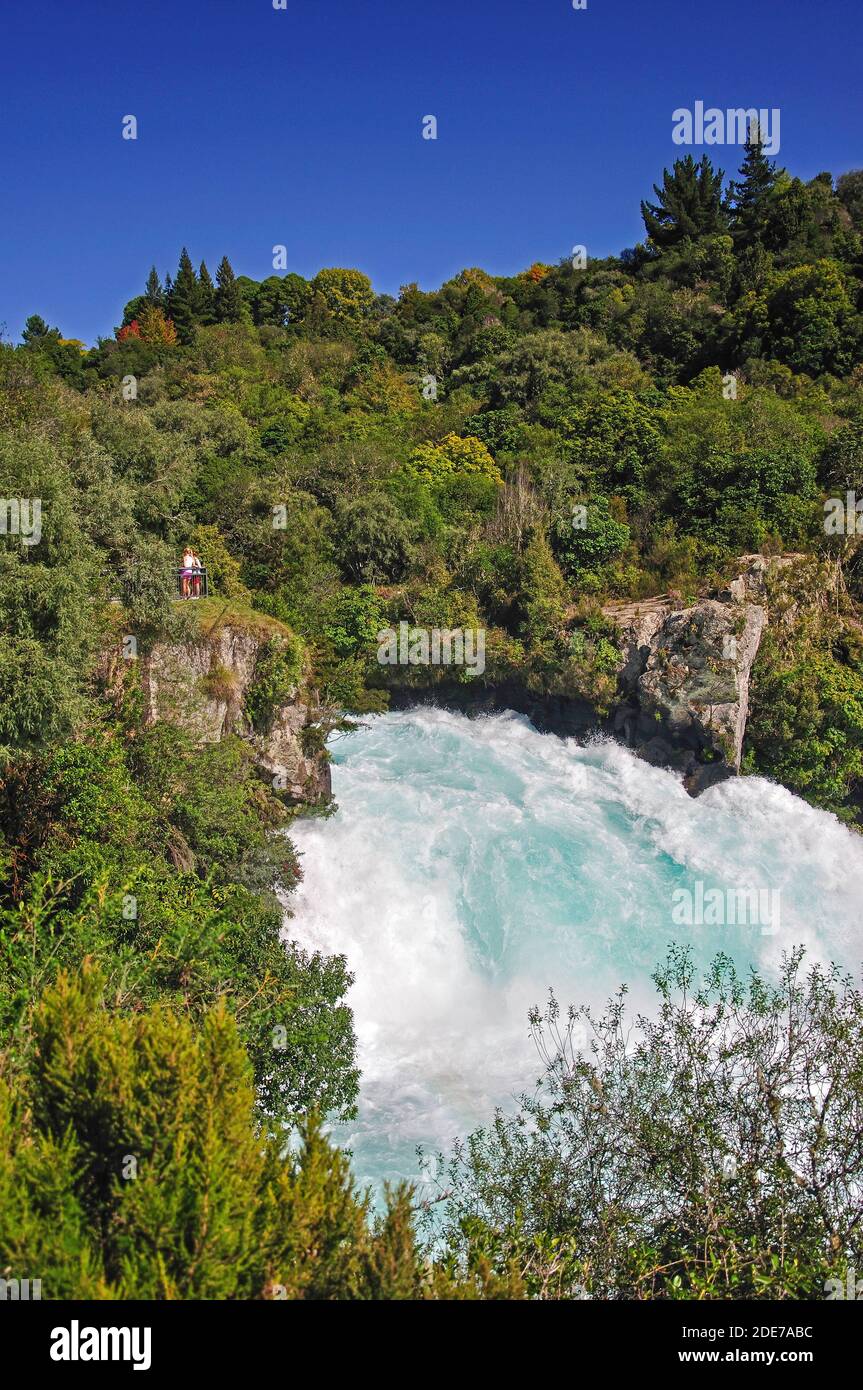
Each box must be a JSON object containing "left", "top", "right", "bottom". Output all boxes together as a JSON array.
[{"left": 0, "top": 965, "right": 424, "bottom": 1300}]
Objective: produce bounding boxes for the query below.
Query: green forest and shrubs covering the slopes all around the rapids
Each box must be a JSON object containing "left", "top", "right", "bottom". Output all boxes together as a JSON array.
[{"left": 0, "top": 135, "right": 863, "bottom": 1297}]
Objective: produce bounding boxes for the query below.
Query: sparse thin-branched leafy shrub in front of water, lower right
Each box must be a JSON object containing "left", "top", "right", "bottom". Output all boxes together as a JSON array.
[{"left": 429, "top": 949, "right": 863, "bottom": 1300}]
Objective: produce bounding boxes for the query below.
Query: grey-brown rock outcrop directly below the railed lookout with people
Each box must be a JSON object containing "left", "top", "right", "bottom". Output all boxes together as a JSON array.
[{"left": 142, "top": 624, "right": 331, "bottom": 801}]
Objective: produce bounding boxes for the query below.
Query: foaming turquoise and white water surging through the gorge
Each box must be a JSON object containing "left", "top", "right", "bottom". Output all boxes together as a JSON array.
[{"left": 285, "top": 709, "right": 863, "bottom": 1184}]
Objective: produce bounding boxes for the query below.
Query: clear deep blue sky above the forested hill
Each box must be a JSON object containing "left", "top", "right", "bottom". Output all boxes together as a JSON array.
[{"left": 0, "top": 0, "right": 863, "bottom": 343}]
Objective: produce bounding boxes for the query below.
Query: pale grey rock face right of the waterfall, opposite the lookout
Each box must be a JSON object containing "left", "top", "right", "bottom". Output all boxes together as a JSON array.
[{"left": 606, "top": 599, "right": 767, "bottom": 792}]
